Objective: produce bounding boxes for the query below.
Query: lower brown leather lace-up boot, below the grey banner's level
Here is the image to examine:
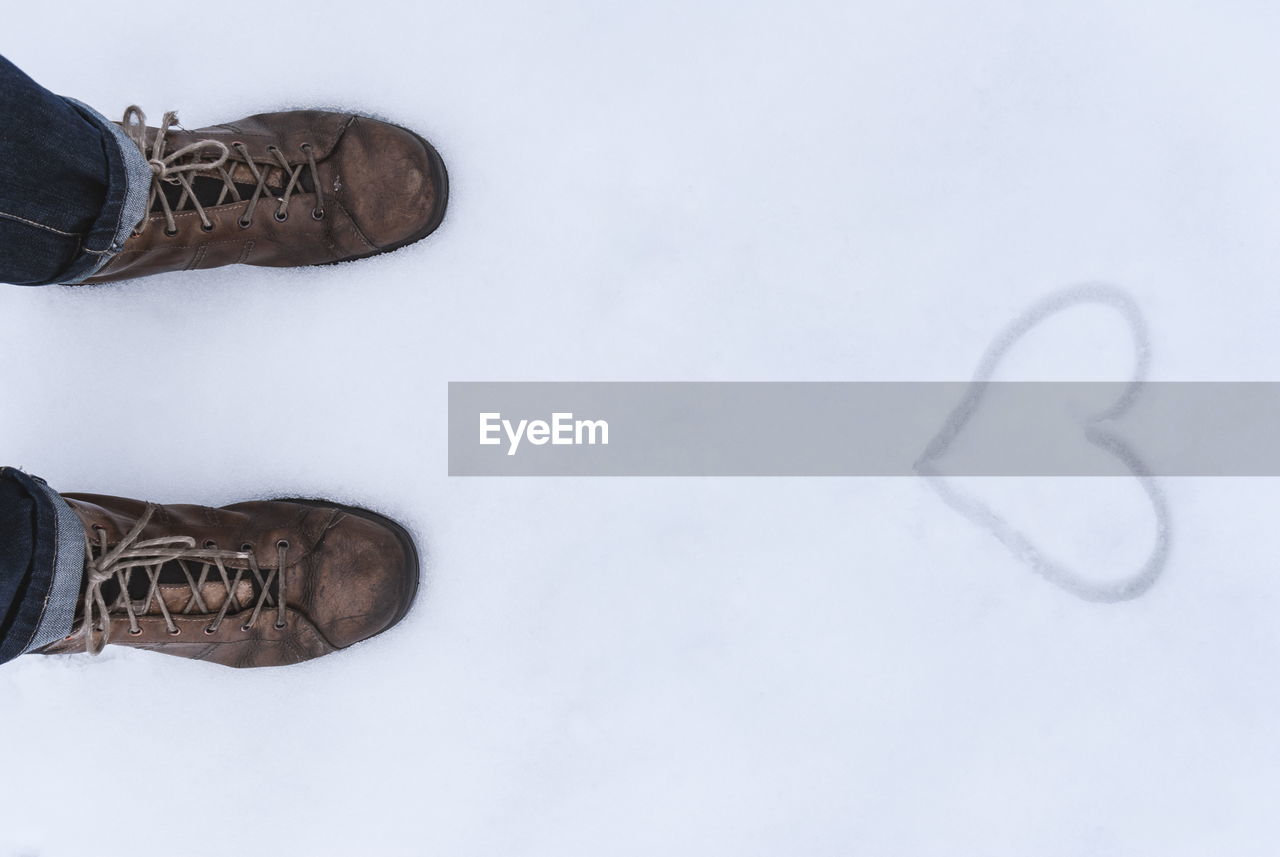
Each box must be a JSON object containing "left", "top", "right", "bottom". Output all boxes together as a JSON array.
[{"left": 38, "top": 494, "right": 419, "bottom": 666}]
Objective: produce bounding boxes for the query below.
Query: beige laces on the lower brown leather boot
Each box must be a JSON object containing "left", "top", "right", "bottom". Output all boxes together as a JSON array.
[{"left": 73, "top": 503, "right": 289, "bottom": 655}]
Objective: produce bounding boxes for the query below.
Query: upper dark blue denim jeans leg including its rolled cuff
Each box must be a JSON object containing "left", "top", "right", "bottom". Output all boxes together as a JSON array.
[{"left": 0, "top": 56, "right": 141, "bottom": 285}]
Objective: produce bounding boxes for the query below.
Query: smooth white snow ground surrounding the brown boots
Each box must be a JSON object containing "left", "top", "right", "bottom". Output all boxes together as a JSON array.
[{"left": 0, "top": 0, "right": 1280, "bottom": 857}]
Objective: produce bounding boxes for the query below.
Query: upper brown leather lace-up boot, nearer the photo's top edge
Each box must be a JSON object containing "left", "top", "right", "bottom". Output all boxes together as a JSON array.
[{"left": 86, "top": 107, "right": 448, "bottom": 283}]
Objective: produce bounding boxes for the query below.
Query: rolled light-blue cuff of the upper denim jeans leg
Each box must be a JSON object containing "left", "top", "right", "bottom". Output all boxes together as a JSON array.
[{"left": 58, "top": 96, "right": 151, "bottom": 285}]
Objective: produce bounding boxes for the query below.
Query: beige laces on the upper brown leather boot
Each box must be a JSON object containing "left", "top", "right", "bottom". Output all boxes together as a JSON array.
[{"left": 120, "top": 105, "right": 324, "bottom": 235}]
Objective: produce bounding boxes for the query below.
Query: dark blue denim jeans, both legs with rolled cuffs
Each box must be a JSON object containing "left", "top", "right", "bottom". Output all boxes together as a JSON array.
[{"left": 0, "top": 56, "right": 138, "bottom": 663}]
